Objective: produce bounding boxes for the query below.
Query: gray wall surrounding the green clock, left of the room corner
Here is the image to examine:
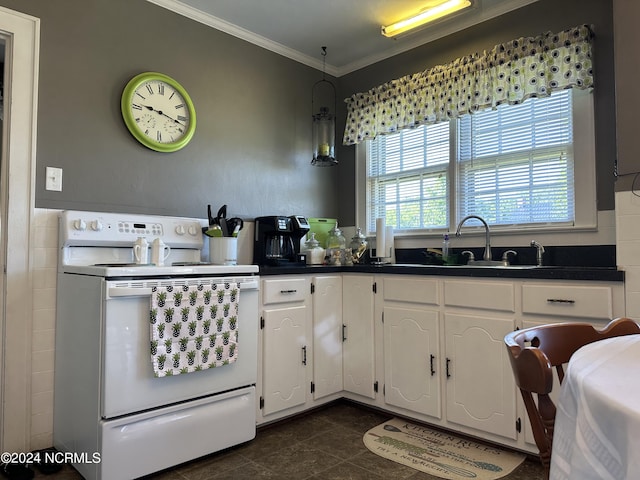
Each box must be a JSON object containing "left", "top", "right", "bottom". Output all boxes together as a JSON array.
[{"left": 0, "top": 0, "right": 338, "bottom": 217}]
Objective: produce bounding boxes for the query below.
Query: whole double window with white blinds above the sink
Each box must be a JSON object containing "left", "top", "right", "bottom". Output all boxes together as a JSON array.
[{"left": 364, "top": 90, "right": 595, "bottom": 233}]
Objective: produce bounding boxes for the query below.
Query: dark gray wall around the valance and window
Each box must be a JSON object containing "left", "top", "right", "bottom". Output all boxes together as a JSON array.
[{"left": 337, "top": 0, "right": 616, "bottom": 225}]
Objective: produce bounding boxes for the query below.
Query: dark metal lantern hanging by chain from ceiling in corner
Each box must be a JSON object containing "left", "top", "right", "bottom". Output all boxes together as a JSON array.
[{"left": 311, "top": 47, "right": 338, "bottom": 167}]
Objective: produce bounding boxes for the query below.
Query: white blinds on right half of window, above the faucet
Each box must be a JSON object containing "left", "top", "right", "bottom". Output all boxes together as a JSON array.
[{"left": 457, "top": 90, "right": 575, "bottom": 229}]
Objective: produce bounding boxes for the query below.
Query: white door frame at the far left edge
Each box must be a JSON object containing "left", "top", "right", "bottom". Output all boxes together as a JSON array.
[{"left": 0, "top": 7, "right": 40, "bottom": 452}]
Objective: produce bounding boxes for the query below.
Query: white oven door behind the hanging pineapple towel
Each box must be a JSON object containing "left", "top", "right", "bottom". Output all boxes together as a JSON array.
[{"left": 101, "top": 276, "right": 259, "bottom": 419}]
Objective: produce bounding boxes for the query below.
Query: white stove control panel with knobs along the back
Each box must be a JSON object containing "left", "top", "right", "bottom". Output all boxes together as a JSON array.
[{"left": 60, "top": 210, "right": 207, "bottom": 249}]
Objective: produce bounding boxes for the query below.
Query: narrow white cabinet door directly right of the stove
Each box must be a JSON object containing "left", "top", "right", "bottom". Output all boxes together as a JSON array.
[{"left": 262, "top": 305, "right": 307, "bottom": 415}]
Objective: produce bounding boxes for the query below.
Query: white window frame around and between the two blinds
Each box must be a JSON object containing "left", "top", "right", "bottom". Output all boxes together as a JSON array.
[{"left": 355, "top": 88, "right": 598, "bottom": 238}]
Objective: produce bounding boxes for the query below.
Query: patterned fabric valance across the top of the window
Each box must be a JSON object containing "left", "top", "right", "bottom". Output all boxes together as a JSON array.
[{"left": 343, "top": 25, "right": 593, "bottom": 145}]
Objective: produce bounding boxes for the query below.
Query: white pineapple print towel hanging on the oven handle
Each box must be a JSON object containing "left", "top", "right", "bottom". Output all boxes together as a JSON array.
[{"left": 150, "top": 283, "right": 240, "bottom": 377}]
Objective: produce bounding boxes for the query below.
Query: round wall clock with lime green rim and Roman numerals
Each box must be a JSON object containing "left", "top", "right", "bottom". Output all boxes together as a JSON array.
[{"left": 120, "top": 72, "right": 196, "bottom": 152}]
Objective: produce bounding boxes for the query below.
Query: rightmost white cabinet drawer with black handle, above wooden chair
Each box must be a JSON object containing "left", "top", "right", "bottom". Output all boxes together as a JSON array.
[{"left": 522, "top": 285, "right": 613, "bottom": 319}]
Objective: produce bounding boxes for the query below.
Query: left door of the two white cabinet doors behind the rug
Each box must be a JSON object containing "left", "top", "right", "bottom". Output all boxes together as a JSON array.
[{"left": 384, "top": 306, "right": 441, "bottom": 418}]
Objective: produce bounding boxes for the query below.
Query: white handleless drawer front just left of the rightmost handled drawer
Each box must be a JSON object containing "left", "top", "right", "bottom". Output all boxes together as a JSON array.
[{"left": 444, "top": 280, "right": 516, "bottom": 312}]
